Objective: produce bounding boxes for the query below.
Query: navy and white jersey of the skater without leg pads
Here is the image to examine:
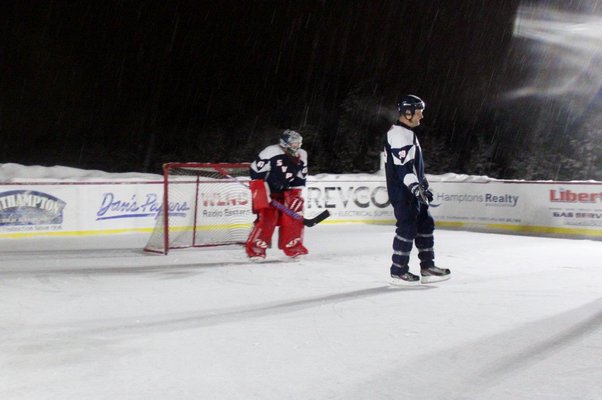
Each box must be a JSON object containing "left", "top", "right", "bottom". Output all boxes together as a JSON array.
[{"left": 385, "top": 124, "right": 428, "bottom": 204}]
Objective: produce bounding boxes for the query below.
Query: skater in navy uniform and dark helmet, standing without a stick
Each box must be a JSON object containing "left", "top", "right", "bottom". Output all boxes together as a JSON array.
[{"left": 385, "top": 95, "right": 450, "bottom": 286}]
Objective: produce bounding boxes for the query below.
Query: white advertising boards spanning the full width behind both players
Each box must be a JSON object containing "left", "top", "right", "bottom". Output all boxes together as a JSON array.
[{"left": 0, "top": 174, "right": 602, "bottom": 239}]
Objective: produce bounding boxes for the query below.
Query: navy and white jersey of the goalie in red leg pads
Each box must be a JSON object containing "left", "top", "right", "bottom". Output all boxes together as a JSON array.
[{"left": 250, "top": 144, "right": 307, "bottom": 193}]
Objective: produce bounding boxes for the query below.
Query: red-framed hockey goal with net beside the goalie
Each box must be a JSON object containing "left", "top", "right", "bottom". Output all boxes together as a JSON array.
[{"left": 144, "top": 163, "right": 254, "bottom": 254}]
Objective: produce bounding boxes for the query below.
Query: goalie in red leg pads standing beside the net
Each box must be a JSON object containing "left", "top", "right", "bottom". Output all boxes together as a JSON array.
[{"left": 245, "top": 129, "right": 307, "bottom": 260}]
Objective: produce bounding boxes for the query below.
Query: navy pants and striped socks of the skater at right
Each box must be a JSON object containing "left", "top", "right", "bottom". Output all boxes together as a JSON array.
[{"left": 391, "top": 203, "right": 435, "bottom": 273}]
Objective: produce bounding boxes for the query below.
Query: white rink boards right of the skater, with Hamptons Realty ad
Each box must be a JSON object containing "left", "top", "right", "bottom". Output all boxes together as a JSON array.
[{"left": 431, "top": 181, "right": 602, "bottom": 237}]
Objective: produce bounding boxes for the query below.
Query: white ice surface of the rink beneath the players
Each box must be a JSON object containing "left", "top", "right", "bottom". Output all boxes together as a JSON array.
[{"left": 0, "top": 224, "right": 602, "bottom": 400}]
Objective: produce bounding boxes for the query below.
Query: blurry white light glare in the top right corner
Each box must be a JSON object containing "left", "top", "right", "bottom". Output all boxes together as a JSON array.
[{"left": 508, "top": 1, "right": 602, "bottom": 101}]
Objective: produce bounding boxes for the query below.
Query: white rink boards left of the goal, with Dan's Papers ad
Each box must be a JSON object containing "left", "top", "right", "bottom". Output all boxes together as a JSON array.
[{"left": 0, "top": 183, "right": 164, "bottom": 237}]
